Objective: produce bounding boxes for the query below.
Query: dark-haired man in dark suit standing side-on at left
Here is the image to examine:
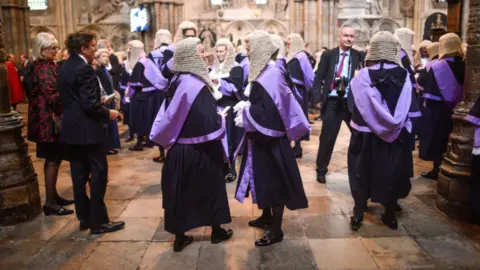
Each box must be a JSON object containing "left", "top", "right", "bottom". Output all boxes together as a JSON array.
[{"left": 57, "top": 32, "right": 125, "bottom": 234}]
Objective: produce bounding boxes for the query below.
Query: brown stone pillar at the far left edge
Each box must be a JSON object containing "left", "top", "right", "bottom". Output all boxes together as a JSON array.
[{"left": 0, "top": 0, "right": 40, "bottom": 225}]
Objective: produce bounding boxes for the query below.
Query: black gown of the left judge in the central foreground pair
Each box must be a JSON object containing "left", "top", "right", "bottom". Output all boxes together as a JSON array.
[{"left": 162, "top": 87, "right": 231, "bottom": 234}]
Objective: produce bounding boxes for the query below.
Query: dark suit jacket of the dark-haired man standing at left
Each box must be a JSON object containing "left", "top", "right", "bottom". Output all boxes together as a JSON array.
[{"left": 57, "top": 54, "right": 110, "bottom": 145}]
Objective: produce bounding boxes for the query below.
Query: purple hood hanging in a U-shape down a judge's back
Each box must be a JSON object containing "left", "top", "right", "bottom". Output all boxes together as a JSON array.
[{"left": 351, "top": 64, "right": 412, "bottom": 143}]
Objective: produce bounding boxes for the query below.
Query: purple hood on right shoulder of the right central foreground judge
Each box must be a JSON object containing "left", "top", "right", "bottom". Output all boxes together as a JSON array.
[{"left": 248, "top": 65, "right": 311, "bottom": 141}]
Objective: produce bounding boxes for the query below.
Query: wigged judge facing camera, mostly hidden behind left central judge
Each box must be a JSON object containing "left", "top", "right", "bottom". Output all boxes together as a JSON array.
[{"left": 162, "top": 21, "right": 198, "bottom": 80}]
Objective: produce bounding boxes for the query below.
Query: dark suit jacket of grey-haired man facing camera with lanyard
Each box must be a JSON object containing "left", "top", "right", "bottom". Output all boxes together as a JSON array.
[{"left": 312, "top": 47, "right": 363, "bottom": 112}]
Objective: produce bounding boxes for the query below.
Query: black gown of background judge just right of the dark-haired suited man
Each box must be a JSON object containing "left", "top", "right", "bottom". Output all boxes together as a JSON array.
[{"left": 129, "top": 62, "right": 153, "bottom": 137}]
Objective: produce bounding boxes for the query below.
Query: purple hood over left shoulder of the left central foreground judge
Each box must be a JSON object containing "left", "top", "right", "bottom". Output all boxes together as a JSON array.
[{"left": 150, "top": 74, "right": 205, "bottom": 149}]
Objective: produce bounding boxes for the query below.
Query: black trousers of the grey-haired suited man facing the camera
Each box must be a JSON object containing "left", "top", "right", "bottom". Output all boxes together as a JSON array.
[{"left": 317, "top": 98, "right": 352, "bottom": 175}]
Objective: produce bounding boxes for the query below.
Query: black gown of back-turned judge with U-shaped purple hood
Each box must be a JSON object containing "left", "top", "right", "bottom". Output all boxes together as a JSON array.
[{"left": 348, "top": 67, "right": 418, "bottom": 205}]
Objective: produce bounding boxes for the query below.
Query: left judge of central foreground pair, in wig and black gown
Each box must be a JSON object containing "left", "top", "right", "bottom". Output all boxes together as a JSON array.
[{"left": 150, "top": 38, "right": 233, "bottom": 252}]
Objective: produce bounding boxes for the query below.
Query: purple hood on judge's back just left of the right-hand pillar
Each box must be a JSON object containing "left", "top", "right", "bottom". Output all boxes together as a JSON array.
[{"left": 432, "top": 58, "right": 464, "bottom": 109}]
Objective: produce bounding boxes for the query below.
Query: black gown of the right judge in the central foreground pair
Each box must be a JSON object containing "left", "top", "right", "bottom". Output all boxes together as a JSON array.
[{"left": 236, "top": 82, "right": 308, "bottom": 210}]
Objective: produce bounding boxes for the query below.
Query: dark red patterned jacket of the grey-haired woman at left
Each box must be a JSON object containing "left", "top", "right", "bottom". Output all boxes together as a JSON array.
[{"left": 27, "top": 60, "right": 63, "bottom": 143}]
